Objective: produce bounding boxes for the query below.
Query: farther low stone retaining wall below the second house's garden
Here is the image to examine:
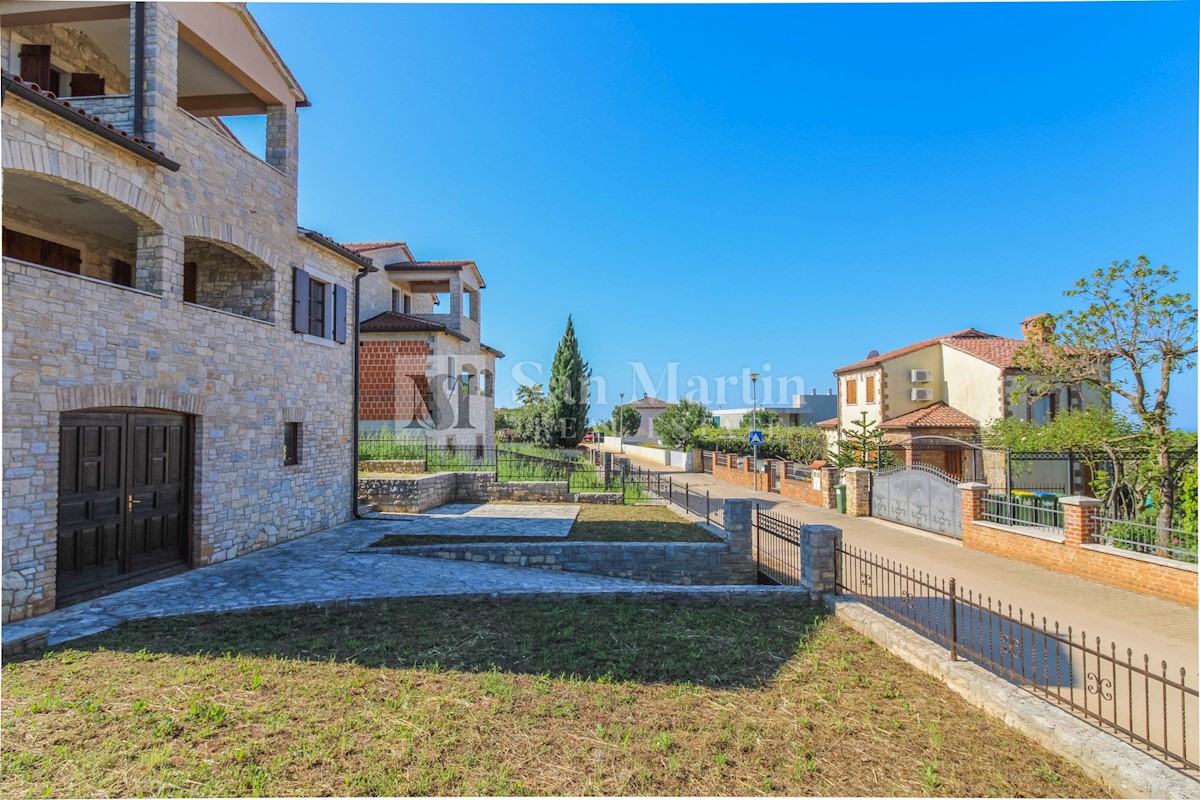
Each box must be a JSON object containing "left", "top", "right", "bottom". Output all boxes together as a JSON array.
[{"left": 359, "top": 473, "right": 625, "bottom": 513}]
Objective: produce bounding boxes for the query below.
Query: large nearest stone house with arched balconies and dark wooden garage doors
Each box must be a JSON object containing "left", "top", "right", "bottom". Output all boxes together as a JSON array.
[{"left": 0, "top": 2, "right": 370, "bottom": 621}]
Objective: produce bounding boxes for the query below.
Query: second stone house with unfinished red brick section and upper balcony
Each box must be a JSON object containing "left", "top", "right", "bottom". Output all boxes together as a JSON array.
[{"left": 344, "top": 241, "right": 504, "bottom": 453}]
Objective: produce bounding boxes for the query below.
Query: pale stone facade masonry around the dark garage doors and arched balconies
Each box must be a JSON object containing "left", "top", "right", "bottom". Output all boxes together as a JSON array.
[{"left": 0, "top": 4, "right": 358, "bottom": 621}]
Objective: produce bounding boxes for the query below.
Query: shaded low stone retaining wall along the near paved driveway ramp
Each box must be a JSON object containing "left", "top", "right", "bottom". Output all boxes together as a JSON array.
[{"left": 377, "top": 542, "right": 757, "bottom": 585}]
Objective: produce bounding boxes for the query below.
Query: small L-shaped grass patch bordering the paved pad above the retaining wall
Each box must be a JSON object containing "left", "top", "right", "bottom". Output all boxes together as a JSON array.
[{"left": 374, "top": 504, "right": 721, "bottom": 547}]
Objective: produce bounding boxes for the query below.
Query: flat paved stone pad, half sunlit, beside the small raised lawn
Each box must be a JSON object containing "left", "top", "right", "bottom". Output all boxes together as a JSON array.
[{"left": 364, "top": 503, "right": 580, "bottom": 539}]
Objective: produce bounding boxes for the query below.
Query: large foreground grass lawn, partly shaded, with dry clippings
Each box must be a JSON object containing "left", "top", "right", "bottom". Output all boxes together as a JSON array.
[{"left": 0, "top": 599, "right": 1108, "bottom": 796}]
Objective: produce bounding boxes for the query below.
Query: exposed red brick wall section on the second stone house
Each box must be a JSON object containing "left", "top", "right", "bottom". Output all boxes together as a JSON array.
[{"left": 359, "top": 339, "right": 433, "bottom": 421}]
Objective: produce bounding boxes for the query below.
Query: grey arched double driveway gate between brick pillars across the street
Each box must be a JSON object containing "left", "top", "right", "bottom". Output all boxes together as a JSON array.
[{"left": 871, "top": 464, "right": 962, "bottom": 539}]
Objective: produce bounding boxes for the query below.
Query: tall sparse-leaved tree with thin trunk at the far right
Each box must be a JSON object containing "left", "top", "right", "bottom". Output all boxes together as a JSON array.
[{"left": 1014, "top": 255, "right": 1196, "bottom": 545}]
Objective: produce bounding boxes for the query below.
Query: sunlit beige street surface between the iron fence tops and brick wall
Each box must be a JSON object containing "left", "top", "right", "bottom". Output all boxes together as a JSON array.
[{"left": 631, "top": 459, "right": 1200, "bottom": 671}]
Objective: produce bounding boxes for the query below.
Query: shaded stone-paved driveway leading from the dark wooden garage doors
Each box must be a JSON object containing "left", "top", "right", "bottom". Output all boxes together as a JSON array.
[{"left": 2, "top": 505, "right": 796, "bottom": 644}]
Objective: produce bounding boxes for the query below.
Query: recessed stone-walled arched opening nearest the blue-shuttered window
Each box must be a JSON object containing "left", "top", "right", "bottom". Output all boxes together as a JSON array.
[{"left": 184, "top": 239, "right": 275, "bottom": 321}]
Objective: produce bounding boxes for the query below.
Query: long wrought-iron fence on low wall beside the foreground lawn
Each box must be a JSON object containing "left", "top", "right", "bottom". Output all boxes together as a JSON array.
[{"left": 835, "top": 545, "right": 1200, "bottom": 769}]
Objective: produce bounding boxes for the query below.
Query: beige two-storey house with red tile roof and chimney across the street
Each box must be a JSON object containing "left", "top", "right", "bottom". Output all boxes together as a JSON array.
[{"left": 818, "top": 314, "right": 1108, "bottom": 476}]
